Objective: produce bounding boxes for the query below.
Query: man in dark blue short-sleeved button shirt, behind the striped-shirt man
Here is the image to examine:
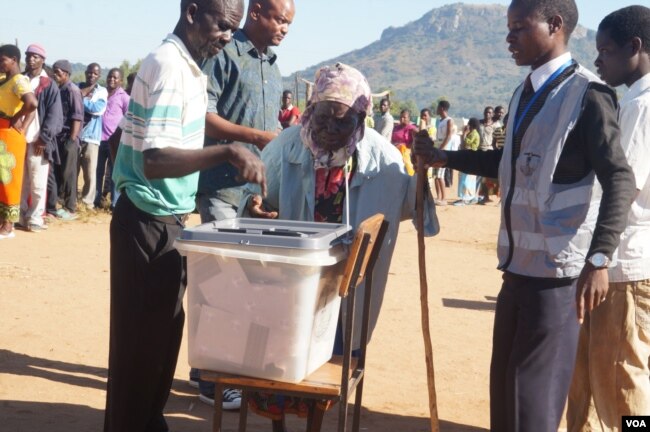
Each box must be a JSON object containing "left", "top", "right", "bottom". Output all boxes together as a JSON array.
[{"left": 190, "top": 0, "right": 295, "bottom": 409}]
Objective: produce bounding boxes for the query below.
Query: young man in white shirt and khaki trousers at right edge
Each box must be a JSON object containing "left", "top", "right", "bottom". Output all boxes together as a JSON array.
[{"left": 567, "top": 6, "right": 650, "bottom": 432}]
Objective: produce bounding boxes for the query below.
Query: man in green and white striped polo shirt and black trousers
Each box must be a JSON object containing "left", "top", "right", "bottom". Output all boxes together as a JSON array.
[{"left": 104, "top": 0, "right": 266, "bottom": 432}]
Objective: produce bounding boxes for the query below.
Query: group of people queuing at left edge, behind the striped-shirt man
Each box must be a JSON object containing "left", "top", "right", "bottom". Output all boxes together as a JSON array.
[{"left": 0, "top": 47, "right": 135, "bottom": 239}]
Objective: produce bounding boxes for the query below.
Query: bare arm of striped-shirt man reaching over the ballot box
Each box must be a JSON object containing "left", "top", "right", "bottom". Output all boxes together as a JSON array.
[{"left": 143, "top": 145, "right": 266, "bottom": 195}]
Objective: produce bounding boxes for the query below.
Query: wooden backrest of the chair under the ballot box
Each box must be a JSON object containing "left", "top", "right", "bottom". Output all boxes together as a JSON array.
[{"left": 339, "top": 213, "right": 384, "bottom": 297}]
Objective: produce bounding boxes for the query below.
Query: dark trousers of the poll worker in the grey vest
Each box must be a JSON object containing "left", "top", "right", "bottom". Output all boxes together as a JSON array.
[{"left": 490, "top": 273, "right": 579, "bottom": 432}]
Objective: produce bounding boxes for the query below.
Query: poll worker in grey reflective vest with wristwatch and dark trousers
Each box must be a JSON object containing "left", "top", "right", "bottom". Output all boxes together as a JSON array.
[{"left": 414, "top": 0, "right": 635, "bottom": 432}]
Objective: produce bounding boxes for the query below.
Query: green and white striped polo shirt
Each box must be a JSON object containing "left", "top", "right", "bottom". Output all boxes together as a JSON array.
[{"left": 113, "top": 34, "right": 208, "bottom": 216}]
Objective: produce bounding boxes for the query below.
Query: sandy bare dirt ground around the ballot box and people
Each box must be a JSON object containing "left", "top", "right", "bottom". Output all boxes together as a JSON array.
[{"left": 0, "top": 187, "right": 512, "bottom": 432}]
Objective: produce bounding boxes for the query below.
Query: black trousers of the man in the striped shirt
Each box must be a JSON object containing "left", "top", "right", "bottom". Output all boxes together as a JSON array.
[{"left": 104, "top": 194, "right": 186, "bottom": 432}]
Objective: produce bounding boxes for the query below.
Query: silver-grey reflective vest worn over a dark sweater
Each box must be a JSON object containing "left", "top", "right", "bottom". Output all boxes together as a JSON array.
[{"left": 497, "top": 66, "right": 601, "bottom": 278}]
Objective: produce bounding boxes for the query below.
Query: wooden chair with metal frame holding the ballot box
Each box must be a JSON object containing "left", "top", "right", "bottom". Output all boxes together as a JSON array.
[{"left": 201, "top": 214, "right": 388, "bottom": 432}]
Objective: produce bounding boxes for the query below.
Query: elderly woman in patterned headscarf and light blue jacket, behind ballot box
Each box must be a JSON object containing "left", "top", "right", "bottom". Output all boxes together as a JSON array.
[{"left": 239, "top": 63, "right": 438, "bottom": 428}]
